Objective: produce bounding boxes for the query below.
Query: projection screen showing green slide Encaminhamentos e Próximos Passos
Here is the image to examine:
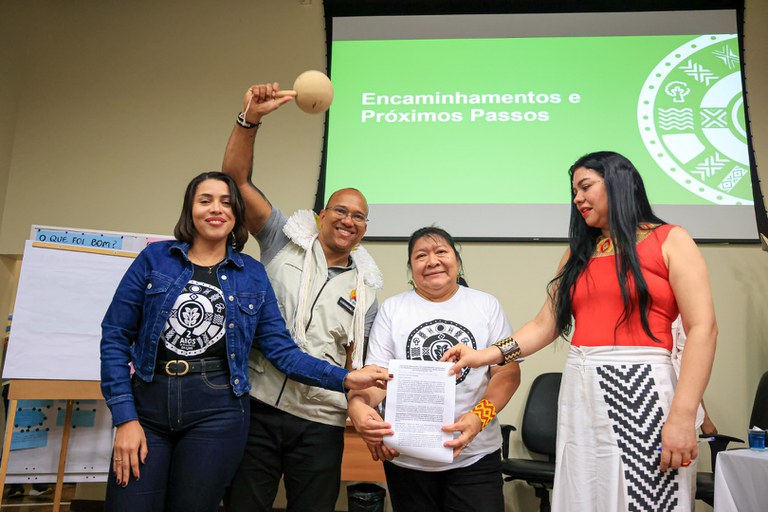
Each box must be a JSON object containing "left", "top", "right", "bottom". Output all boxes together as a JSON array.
[{"left": 320, "top": 4, "right": 758, "bottom": 241}]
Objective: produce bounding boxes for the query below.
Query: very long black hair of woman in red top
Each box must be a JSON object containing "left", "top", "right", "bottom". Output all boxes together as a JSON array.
[{"left": 547, "top": 151, "right": 666, "bottom": 342}]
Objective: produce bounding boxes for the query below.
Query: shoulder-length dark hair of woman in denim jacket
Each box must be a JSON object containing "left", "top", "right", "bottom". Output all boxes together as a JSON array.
[{"left": 173, "top": 171, "right": 248, "bottom": 252}]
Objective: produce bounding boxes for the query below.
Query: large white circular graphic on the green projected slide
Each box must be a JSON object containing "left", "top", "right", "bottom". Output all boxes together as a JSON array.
[{"left": 637, "top": 35, "right": 753, "bottom": 205}]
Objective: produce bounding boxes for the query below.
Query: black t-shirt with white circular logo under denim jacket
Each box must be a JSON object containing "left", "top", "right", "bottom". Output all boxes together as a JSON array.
[{"left": 157, "top": 265, "right": 227, "bottom": 361}]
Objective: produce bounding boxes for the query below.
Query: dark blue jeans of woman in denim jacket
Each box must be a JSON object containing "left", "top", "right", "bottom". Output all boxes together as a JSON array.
[{"left": 104, "top": 370, "right": 249, "bottom": 512}]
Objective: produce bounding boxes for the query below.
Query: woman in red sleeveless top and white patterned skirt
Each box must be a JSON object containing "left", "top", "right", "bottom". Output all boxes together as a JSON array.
[{"left": 443, "top": 151, "right": 717, "bottom": 512}]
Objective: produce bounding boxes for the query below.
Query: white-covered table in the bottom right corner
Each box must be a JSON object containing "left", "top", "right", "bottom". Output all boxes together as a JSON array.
[{"left": 715, "top": 449, "right": 768, "bottom": 512}]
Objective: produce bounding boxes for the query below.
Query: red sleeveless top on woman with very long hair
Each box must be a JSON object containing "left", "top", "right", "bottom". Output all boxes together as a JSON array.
[{"left": 571, "top": 224, "right": 678, "bottom": 350}]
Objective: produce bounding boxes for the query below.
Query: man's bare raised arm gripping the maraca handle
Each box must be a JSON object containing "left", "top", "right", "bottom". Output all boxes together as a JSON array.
[{"left": 221, "top": 83, "right": 292, "bottom": 235}]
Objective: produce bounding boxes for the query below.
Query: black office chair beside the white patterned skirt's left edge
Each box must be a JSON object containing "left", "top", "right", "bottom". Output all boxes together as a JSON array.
[{"left": 501, "top": 373, "right": 562, "bottom": 512}]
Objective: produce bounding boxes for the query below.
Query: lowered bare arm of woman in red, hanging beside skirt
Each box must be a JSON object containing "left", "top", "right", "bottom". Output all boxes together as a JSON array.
[{"left": 659, "top": 228, "right": 717, "bottom": 471}]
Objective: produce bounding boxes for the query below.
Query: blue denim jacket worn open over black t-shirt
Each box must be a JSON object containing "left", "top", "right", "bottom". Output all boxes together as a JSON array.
[{"left": 101, "top": 241, "right": 347, "bottom": 425}]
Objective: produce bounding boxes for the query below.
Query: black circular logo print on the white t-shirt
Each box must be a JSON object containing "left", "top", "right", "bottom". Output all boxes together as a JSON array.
[{"left": 405, "top": 319, "right": 477, "bottom": 384}]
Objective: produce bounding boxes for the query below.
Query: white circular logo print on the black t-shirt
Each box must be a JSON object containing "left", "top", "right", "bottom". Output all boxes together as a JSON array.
[{"left": 161, "top": 281, "right": 226, "bottom": 356}]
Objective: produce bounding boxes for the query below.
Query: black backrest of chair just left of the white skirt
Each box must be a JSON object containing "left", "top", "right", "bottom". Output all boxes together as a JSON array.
[{"left": 522, "top": 373, "right": 563, "bottom": 459}]
